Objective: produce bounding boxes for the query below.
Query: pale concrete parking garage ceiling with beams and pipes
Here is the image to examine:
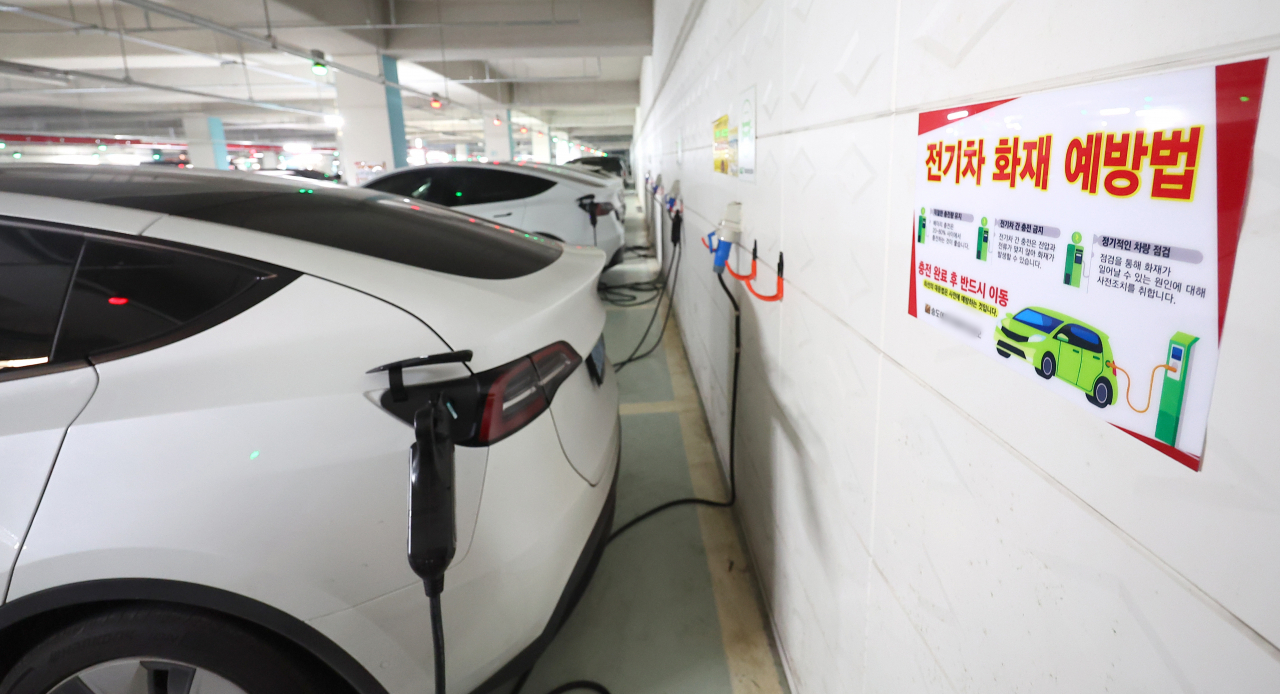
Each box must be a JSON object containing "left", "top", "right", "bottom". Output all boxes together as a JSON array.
[{"left": 0, "top": 0, "right": 653, "bottom": 149}]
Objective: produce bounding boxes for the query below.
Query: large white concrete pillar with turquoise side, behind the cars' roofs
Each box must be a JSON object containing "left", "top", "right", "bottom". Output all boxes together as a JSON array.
[{"left": 334, "top": 55, "right": 408, "bottom": 186}]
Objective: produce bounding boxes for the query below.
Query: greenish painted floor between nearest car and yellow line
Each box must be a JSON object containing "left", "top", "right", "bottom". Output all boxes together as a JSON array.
[{"left": 509, "top": 379, "right": 732, "bottom": 694}]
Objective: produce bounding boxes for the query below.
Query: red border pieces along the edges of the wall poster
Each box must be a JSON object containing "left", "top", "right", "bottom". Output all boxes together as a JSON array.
[{"left": 906, "top": 58, "right": 1267, "bottom": 472}]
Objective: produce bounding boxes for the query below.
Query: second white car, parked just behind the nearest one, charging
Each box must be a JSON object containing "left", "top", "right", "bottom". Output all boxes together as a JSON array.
[{"left": 365, "top": 161, "right": 626, "bottom": 265}]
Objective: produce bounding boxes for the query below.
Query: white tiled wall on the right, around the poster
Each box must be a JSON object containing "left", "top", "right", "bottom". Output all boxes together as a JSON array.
[{"left": 634, "top": 0, "right": 1280, "bottom": 694}]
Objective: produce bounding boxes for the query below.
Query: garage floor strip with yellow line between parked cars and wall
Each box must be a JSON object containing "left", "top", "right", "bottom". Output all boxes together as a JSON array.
[{"left": 491, "top": 197, "right": 787, "bottom": 694}]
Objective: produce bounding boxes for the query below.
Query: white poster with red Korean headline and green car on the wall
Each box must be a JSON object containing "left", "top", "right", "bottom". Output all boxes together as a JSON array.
[{"left": 908, "top": 60, "right": 1267, "bottom": 470}]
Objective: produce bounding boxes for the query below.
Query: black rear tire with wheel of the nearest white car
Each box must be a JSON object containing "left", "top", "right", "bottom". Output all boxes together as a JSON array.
[{"left": 0, "top": 606, "right": 332, "bottom": 694}]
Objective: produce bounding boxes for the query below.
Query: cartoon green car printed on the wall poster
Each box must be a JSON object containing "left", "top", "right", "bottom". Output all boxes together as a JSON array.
[{"left": 996, "top": 306, "right": 1116, "bottom": 407}]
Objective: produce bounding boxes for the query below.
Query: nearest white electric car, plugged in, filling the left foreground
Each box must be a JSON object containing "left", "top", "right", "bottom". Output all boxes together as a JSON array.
[{"left": 0, "top": 165, "right": 620, "bottom": 694}]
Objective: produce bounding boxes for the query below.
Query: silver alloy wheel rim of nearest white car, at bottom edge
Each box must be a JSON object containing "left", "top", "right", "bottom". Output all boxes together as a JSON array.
[{"left": 49, "top": 658, "right": 246, "bottom": 694}]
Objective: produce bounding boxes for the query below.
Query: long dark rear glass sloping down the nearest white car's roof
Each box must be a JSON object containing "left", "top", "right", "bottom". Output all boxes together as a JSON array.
[{"left": 0, "top": 165, "right": 563, "bottom": 279}]
